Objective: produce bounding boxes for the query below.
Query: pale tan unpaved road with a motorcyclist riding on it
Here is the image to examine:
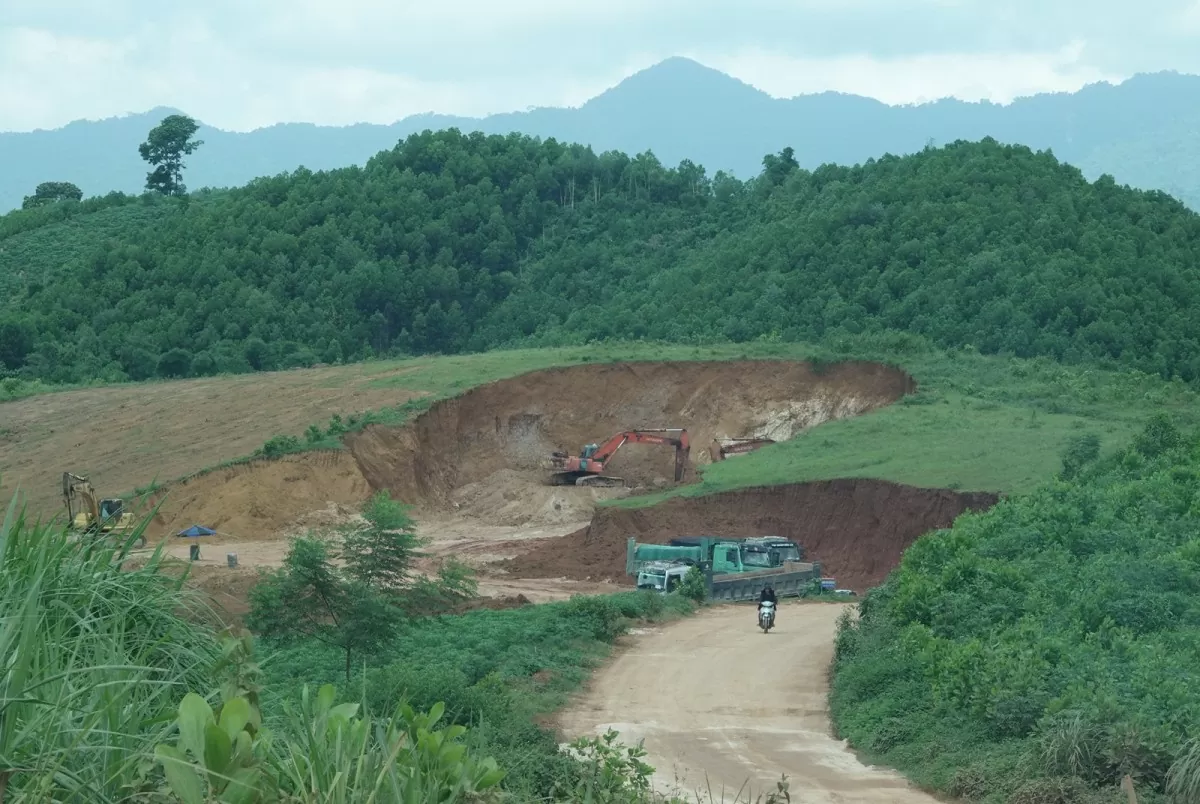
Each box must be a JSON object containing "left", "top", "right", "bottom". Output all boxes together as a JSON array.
[{"left": 559, "top": 602, "right": 937, "bottom": 804}]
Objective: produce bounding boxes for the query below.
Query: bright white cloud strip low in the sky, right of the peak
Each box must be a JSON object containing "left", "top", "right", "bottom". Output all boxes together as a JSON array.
[{"left": 707, "top": 42, "right": 1124, "bottom": 104}]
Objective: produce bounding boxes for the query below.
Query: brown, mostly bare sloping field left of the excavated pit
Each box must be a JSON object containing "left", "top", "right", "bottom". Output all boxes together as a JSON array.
[{"left": 0, "top": 366, "right": 421, "bottom": 514}]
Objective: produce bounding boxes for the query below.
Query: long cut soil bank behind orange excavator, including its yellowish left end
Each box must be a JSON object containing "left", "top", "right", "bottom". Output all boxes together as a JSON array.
[{"left": 142, "top": 360, "right": 916, "bottom": 540}]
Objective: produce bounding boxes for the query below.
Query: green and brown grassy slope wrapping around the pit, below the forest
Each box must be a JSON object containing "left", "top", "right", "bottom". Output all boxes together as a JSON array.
[{"left": 0, "top": 342, "right": 1196, "bottom": 520}]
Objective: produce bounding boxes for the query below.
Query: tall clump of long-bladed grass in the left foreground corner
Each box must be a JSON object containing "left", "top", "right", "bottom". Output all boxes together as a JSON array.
[{"left": 0, "top": 498, "right": 217, "bottom": 804}]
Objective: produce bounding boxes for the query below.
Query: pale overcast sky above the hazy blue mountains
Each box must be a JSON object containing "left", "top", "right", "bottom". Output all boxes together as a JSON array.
[{"left": 0, "top": 0, "right": 1200, "bottom": 131}]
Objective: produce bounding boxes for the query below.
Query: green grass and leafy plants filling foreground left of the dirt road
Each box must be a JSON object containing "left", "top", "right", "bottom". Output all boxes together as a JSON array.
[{"left": 0, "top": 487, "right": 801, "bottom": 804}]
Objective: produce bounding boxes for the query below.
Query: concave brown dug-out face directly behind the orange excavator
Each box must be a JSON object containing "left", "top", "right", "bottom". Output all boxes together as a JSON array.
[{"left": 346, "top": 360, "right": 916, "bottom": 515}]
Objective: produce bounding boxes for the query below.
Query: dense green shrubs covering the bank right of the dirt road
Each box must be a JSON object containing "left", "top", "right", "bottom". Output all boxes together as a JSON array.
[{"left": 832, "top": 416, "right": 1200, "bottom": 803}]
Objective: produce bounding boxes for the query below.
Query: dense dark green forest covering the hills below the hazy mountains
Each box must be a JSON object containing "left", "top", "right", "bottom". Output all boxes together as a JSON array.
[{"left": 0, "top": 130, "right": 1200, "bottom": 382}]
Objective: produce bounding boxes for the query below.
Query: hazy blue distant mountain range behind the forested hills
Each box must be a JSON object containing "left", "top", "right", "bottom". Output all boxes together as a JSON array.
[{"left": 0, "top": 58, "right": 1200, "bottom": 211}]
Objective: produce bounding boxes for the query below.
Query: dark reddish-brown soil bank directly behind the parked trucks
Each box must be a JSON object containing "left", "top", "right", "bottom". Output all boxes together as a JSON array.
[{"left": 497, "top": 480, "right": 998, "bottom": 592}]
